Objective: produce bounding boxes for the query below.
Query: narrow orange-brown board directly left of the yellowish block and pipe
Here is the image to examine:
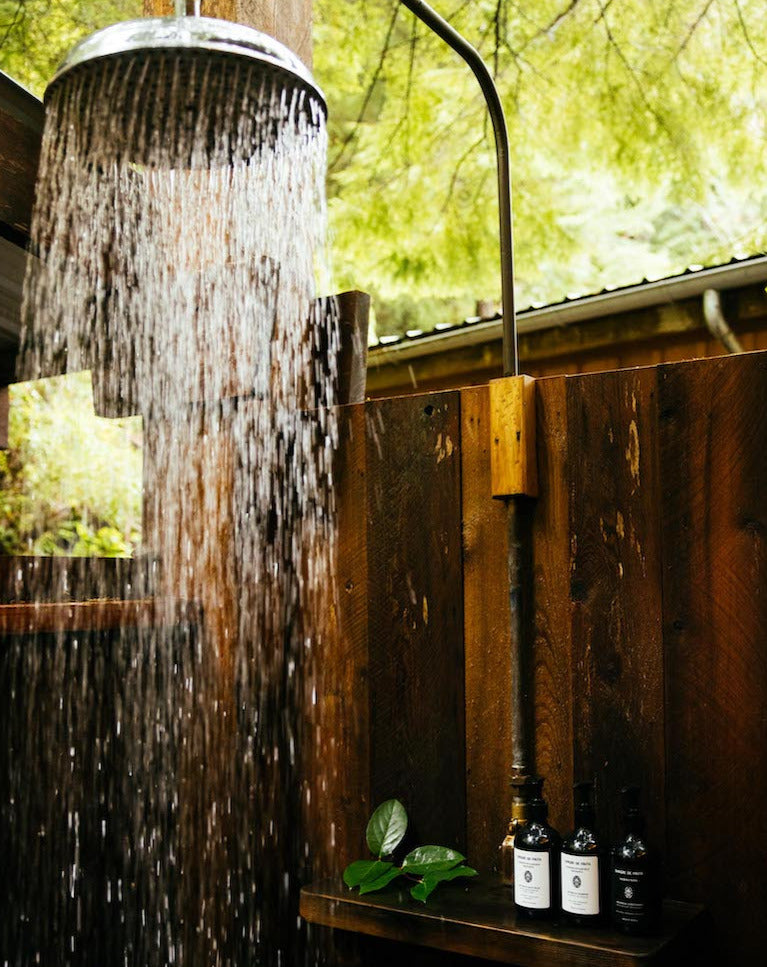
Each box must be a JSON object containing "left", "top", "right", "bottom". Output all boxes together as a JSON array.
[{"left": 461, "top": 387, "right": 511, "bottom": 872}]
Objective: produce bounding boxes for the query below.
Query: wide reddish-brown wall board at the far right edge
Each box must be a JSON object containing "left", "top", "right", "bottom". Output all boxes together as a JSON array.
[{"left": 659, "top": 353, "right": 767, "bottom": 967}]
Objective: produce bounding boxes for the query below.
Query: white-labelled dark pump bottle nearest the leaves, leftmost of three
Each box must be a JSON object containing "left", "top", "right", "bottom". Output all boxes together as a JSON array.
[{"left": 514, "top": 779, "right": 560, "bottom": 919}]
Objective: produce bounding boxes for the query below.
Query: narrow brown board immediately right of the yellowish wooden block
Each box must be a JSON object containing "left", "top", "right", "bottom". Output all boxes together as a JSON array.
[{"left": 533, "top": 377, "right": 573, "bottom": 830}]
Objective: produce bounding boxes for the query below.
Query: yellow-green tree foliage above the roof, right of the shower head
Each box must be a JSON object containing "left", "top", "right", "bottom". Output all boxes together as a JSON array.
[{"left": 314, "top": 0, "right": 767, "bottom": 331}]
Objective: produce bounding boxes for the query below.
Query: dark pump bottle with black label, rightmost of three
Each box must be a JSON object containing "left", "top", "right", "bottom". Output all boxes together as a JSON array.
[{"left": 610, "top": 786, "right": 661, "bottom": 934}]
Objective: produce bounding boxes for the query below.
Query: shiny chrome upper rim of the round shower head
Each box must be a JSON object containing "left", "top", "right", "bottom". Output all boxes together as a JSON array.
[{"left": 45, "top": 17, "right": 327, "bottom": 115}]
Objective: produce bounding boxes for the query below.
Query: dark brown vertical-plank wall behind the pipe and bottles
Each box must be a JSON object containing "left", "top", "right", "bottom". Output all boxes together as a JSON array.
[{"left": 316, "top": 353, "right": 767, "bottom": 967}]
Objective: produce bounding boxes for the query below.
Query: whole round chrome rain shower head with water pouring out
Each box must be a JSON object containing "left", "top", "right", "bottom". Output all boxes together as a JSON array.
[{"left": 45, "top": 16, "right": 327, "bottom": 164}]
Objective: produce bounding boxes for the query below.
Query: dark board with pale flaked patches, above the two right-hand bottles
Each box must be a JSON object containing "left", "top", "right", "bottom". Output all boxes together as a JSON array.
[{"left": 567, "top": 369, "right": 664, "bottom": 845}]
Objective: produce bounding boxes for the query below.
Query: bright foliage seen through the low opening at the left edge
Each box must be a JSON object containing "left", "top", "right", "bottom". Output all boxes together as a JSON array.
[{"left": 0, "top": 373, "right": 142, "bottom": 557}]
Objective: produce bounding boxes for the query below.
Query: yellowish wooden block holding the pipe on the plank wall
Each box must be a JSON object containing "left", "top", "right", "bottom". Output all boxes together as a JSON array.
[{"left": 490, "top": 376, "right": 538, "bottom": 499}]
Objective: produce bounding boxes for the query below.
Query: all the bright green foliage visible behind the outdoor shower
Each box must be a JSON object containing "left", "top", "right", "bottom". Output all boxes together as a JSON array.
[{"left": 0, "top": 0, "right": 767, "bottom": 553}]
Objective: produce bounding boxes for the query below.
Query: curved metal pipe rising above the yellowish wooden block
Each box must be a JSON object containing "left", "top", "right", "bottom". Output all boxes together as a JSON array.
[{"left": 402, "top": 0, "right": 519, "bottom": 376}]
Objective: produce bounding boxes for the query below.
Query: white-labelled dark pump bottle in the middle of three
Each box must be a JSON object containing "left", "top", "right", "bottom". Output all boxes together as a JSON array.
[{"left": 560, "top": 782, "right": 605, "bottom": 924}]
